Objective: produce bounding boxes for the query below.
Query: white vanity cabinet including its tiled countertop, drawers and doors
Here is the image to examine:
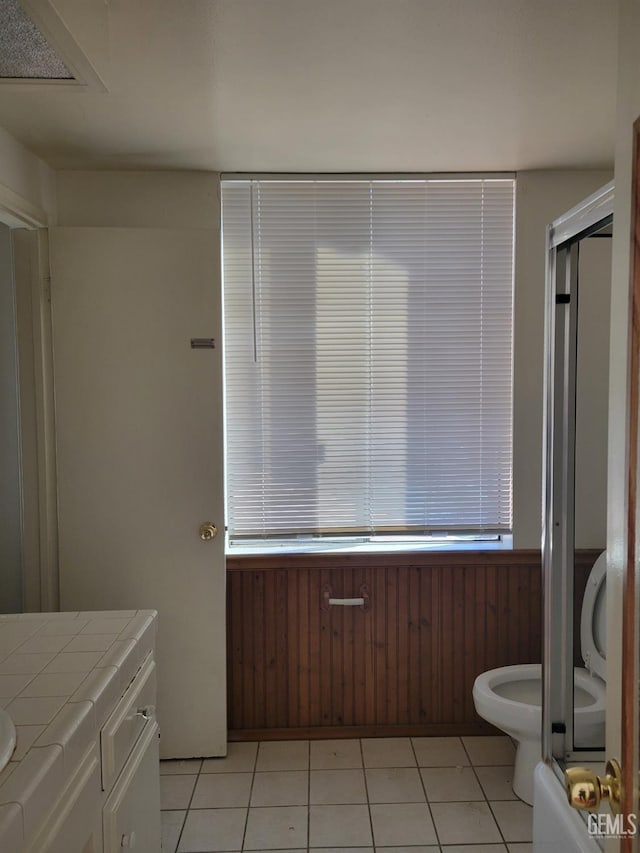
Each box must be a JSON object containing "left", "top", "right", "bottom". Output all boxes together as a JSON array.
[{"left": 0, "top": 611, "right": 161, "bottom": 853}]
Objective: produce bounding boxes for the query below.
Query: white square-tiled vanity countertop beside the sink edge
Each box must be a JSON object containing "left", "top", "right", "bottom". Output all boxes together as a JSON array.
[{"left": 0, "top": 610, "right": 157, "bottom": 849}]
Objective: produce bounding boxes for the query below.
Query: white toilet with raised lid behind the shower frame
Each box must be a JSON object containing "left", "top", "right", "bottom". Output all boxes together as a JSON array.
[{"left": 473, "top": 553, "right": 607, "bottom": 805}]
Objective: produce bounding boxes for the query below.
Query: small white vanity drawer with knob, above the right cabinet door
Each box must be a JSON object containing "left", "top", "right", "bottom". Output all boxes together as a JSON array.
[{"left": 100, "top": 657, "right": 156, "bottom": 791}]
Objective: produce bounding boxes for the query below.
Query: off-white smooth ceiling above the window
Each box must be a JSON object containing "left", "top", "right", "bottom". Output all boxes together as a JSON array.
[{"left": 0, "top": 0, "right": 617, "bottom": 172}]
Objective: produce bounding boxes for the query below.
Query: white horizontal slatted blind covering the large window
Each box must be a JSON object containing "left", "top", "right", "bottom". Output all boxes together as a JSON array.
[{"left": 223, "top": 178, "right": 514, "bottom": 540}]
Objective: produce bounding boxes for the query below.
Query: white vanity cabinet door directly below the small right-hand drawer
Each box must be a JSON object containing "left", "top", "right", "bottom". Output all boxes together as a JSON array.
[{"left": 102, "top": 722, "right": 160, "bottom": 853}]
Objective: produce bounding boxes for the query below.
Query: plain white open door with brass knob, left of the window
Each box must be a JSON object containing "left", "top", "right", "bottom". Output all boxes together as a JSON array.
[{"left": 51, "top": 228, "right": 226, "bottom": 758}]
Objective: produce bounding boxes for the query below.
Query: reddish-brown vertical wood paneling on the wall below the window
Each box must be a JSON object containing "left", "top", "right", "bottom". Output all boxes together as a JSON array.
[{"left": 227, "top": 551, "right": 598, "bottom": 739}]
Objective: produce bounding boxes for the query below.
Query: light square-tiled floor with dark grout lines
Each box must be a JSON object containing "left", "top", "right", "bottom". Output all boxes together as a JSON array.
[{"left": 160, "top": 737, "right": 532, "bottom": 853}]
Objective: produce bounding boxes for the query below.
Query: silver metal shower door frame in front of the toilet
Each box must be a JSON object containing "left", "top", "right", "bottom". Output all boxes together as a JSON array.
[{"left": 542, "top": 176, "right": 614, "bottom": 777}]
